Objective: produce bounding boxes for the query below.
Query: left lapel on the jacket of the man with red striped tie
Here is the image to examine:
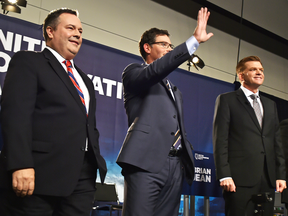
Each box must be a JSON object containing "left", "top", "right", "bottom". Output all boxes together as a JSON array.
[{"left": 43, "top": 49, "right": 86, "bottom": 115}]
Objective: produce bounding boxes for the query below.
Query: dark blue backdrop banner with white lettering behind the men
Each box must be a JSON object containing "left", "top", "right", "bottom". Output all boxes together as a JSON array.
[{"left": 0, "top": 15, "right": 234, "bottom": 214}]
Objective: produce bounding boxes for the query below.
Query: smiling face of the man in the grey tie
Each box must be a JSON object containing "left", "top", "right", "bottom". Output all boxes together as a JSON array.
[{"left": 239, "top": 61, "right": 264, "bottom": 92}]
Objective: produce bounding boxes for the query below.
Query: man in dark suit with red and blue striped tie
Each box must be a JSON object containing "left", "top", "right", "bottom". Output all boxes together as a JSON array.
[{"left": 0, "top": 9, "right": 107, "bottom": 216}]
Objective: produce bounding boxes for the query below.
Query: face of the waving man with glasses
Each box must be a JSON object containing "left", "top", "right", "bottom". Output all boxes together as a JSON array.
[{"left": 145, "top": 35, "right": 172, "bottom": 64}]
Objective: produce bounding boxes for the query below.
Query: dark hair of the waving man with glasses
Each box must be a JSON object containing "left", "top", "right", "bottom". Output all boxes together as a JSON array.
[{"left": 139, "top": 28, "right": 170, "bottom": 60}]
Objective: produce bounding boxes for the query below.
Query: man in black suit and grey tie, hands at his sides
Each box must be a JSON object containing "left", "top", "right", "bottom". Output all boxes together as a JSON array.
[{"left": 213, "top": 56, "right": 286, "bottom": 216}]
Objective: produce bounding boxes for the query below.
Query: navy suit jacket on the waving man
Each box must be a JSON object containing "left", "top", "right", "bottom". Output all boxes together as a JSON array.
[{"left": 117, "top": 43, "right": 194, "bottom": 184}]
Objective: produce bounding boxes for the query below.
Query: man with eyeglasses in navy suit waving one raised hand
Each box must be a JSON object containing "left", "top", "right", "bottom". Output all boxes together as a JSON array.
[{"left": 117, "top": 8, "right": 213, "bottom": 216}]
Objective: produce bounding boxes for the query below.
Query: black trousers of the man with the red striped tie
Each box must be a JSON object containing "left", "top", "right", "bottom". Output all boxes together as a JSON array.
[{"left": 0, "top": 153, "right": 97, "bottom": 216}]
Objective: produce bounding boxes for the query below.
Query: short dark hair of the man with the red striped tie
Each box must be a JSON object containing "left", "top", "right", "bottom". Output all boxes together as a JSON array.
[{"left": 43, "top": 8, "right": 79, "bottom": 42}]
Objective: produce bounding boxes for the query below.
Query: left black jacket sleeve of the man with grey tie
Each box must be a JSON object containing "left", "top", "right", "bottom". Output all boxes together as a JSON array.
[{"left": 213, "top": 95, "right": 232, "bottom": 180}]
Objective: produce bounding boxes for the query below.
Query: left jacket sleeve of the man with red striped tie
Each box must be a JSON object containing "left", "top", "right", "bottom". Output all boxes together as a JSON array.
[{"left": 1, "top": 52, "right": 37, "bottom": 170}]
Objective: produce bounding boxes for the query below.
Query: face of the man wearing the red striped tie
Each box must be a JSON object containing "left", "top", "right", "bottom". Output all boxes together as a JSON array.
[{"left": 46, "top": 13, "right": 83, "bottom": 60}]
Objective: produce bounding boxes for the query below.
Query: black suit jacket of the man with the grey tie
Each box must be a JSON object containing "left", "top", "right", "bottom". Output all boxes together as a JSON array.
[{"left": 213, "top": 89, "right": 285, "bottom": 187}]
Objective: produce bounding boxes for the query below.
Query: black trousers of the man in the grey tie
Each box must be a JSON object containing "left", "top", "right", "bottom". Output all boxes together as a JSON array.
[{"left": 223, "top": 162, "right": 275, "bottom": 216}]
